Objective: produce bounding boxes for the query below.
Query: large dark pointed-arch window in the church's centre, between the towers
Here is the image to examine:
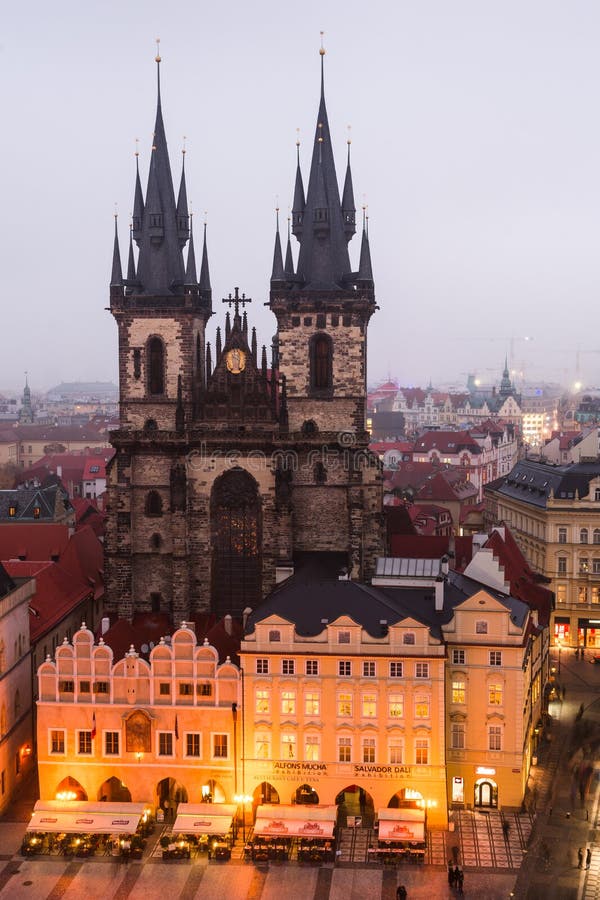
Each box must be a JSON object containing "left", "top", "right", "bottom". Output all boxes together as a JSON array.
[{"left": 211, "top": 468, "right": 261, "bottom": 617}]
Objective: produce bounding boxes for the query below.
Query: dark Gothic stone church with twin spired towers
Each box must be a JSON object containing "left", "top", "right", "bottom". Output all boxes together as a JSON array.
[{"left": 106, "top": 49, "right": 383, "bottom": 623}]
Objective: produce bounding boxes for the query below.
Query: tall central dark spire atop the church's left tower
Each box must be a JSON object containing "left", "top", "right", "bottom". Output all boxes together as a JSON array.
[{"left": 134, "top": 45, "right": 187, "bottom": 296}]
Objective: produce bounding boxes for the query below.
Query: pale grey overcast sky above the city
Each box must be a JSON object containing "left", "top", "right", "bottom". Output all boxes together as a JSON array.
[{"left": 0, "top": 0, "right": 600, "bottom": 389}]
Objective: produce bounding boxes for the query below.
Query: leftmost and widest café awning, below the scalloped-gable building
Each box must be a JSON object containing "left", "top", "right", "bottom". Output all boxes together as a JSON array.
[{"left": 27, "top": 800, "right": 146, "bottom": 834}]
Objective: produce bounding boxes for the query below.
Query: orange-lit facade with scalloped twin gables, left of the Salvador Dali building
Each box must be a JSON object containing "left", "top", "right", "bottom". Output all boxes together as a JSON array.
[{"left": 37, "top": 623, "right": 241, "bottom": 816}]
